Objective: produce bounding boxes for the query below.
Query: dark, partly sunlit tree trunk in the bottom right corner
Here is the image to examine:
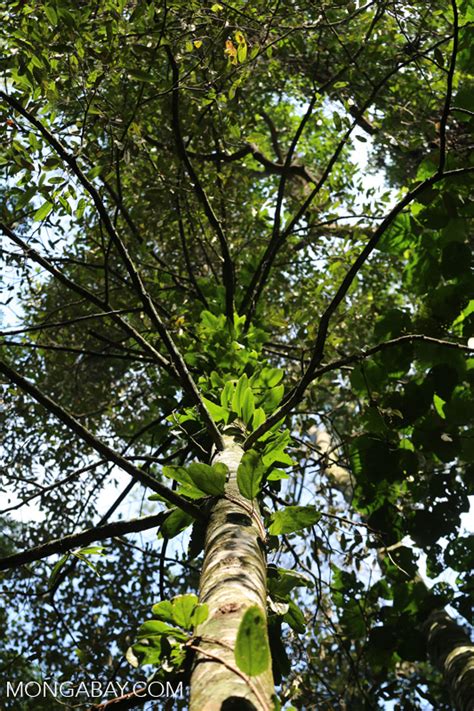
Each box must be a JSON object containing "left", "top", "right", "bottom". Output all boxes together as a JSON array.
[{"left": 423, "top": 610, "right": 474, "bottom": 711}]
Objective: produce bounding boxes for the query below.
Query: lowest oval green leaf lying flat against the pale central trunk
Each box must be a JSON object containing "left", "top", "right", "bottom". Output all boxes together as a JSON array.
[{"left": 235, "top": 605, "right": 270, "bottom": 676}]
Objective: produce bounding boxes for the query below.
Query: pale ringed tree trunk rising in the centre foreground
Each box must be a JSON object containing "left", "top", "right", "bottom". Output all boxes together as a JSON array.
[{"left": 190, "top": 435, "right": 274, "bottom": 711}]
